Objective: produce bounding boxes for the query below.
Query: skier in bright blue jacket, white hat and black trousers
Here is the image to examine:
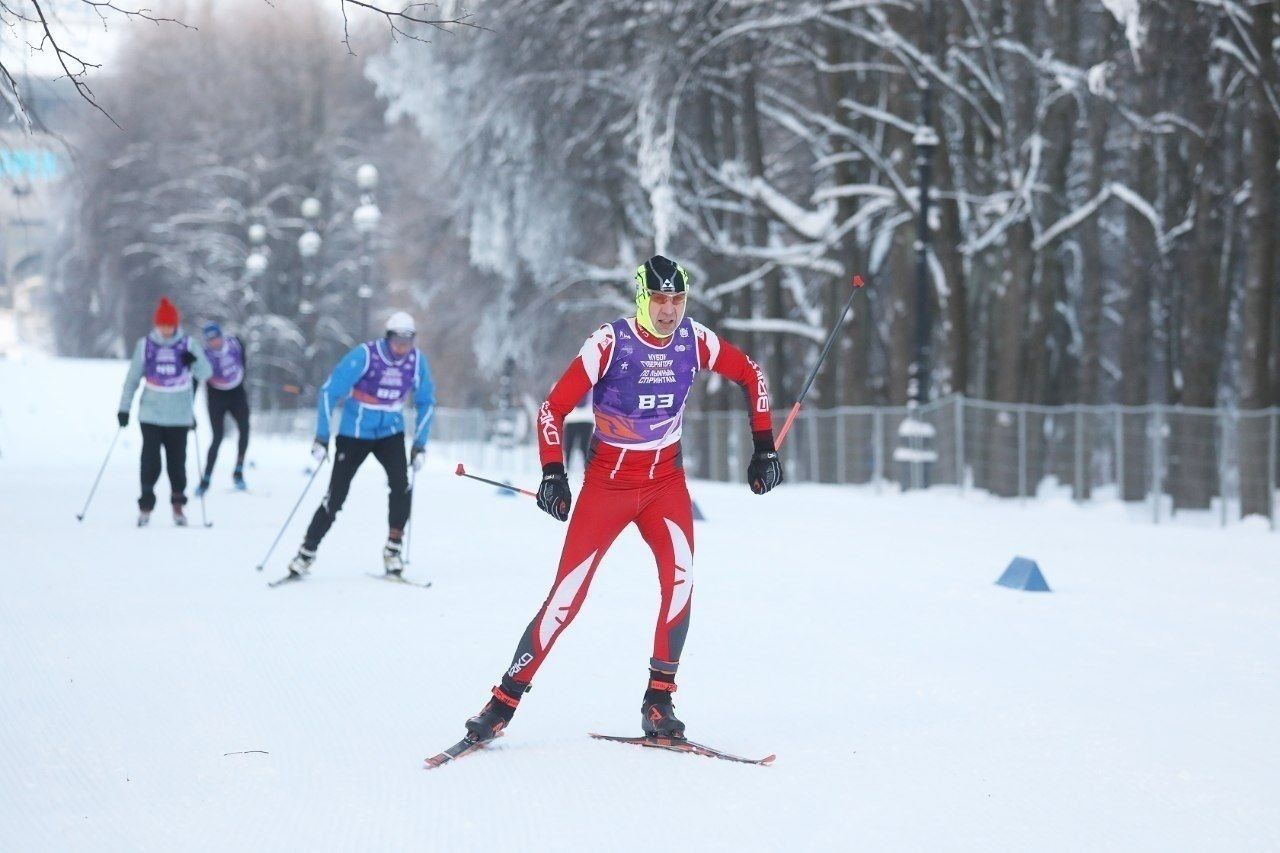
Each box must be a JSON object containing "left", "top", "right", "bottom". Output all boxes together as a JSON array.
[{"left": 289, "top": 311, "right": 435, "bottom": 576}]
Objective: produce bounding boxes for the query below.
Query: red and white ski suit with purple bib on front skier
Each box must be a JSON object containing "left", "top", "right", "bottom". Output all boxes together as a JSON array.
[{"left": 503, "top": 312, "right": 773, "bottom": 699}]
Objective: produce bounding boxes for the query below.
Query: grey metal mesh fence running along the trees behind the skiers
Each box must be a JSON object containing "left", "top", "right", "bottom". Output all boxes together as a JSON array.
[{"left": 256, "top": 394, "right": 1280, "bottom": 530}]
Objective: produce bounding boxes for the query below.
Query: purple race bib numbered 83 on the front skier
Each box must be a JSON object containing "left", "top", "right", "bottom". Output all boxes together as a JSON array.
[{"left": 591, "top": 318, "right": 698, "bottom": 450}]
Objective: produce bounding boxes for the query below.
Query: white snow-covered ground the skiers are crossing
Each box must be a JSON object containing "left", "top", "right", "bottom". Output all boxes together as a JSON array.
[{"left": 0, "top": 361, "right": 1280, "bottom": 850}]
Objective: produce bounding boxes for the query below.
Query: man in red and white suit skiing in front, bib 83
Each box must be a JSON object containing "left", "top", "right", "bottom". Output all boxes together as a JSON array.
[{"left": 467, "top": 255, "right": 782, "bottom": 742}]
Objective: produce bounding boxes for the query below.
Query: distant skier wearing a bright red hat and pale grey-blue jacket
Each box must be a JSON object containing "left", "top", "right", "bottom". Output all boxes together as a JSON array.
[{"left": 116, "top": 297, "right": 212, "bottom": 528}]
